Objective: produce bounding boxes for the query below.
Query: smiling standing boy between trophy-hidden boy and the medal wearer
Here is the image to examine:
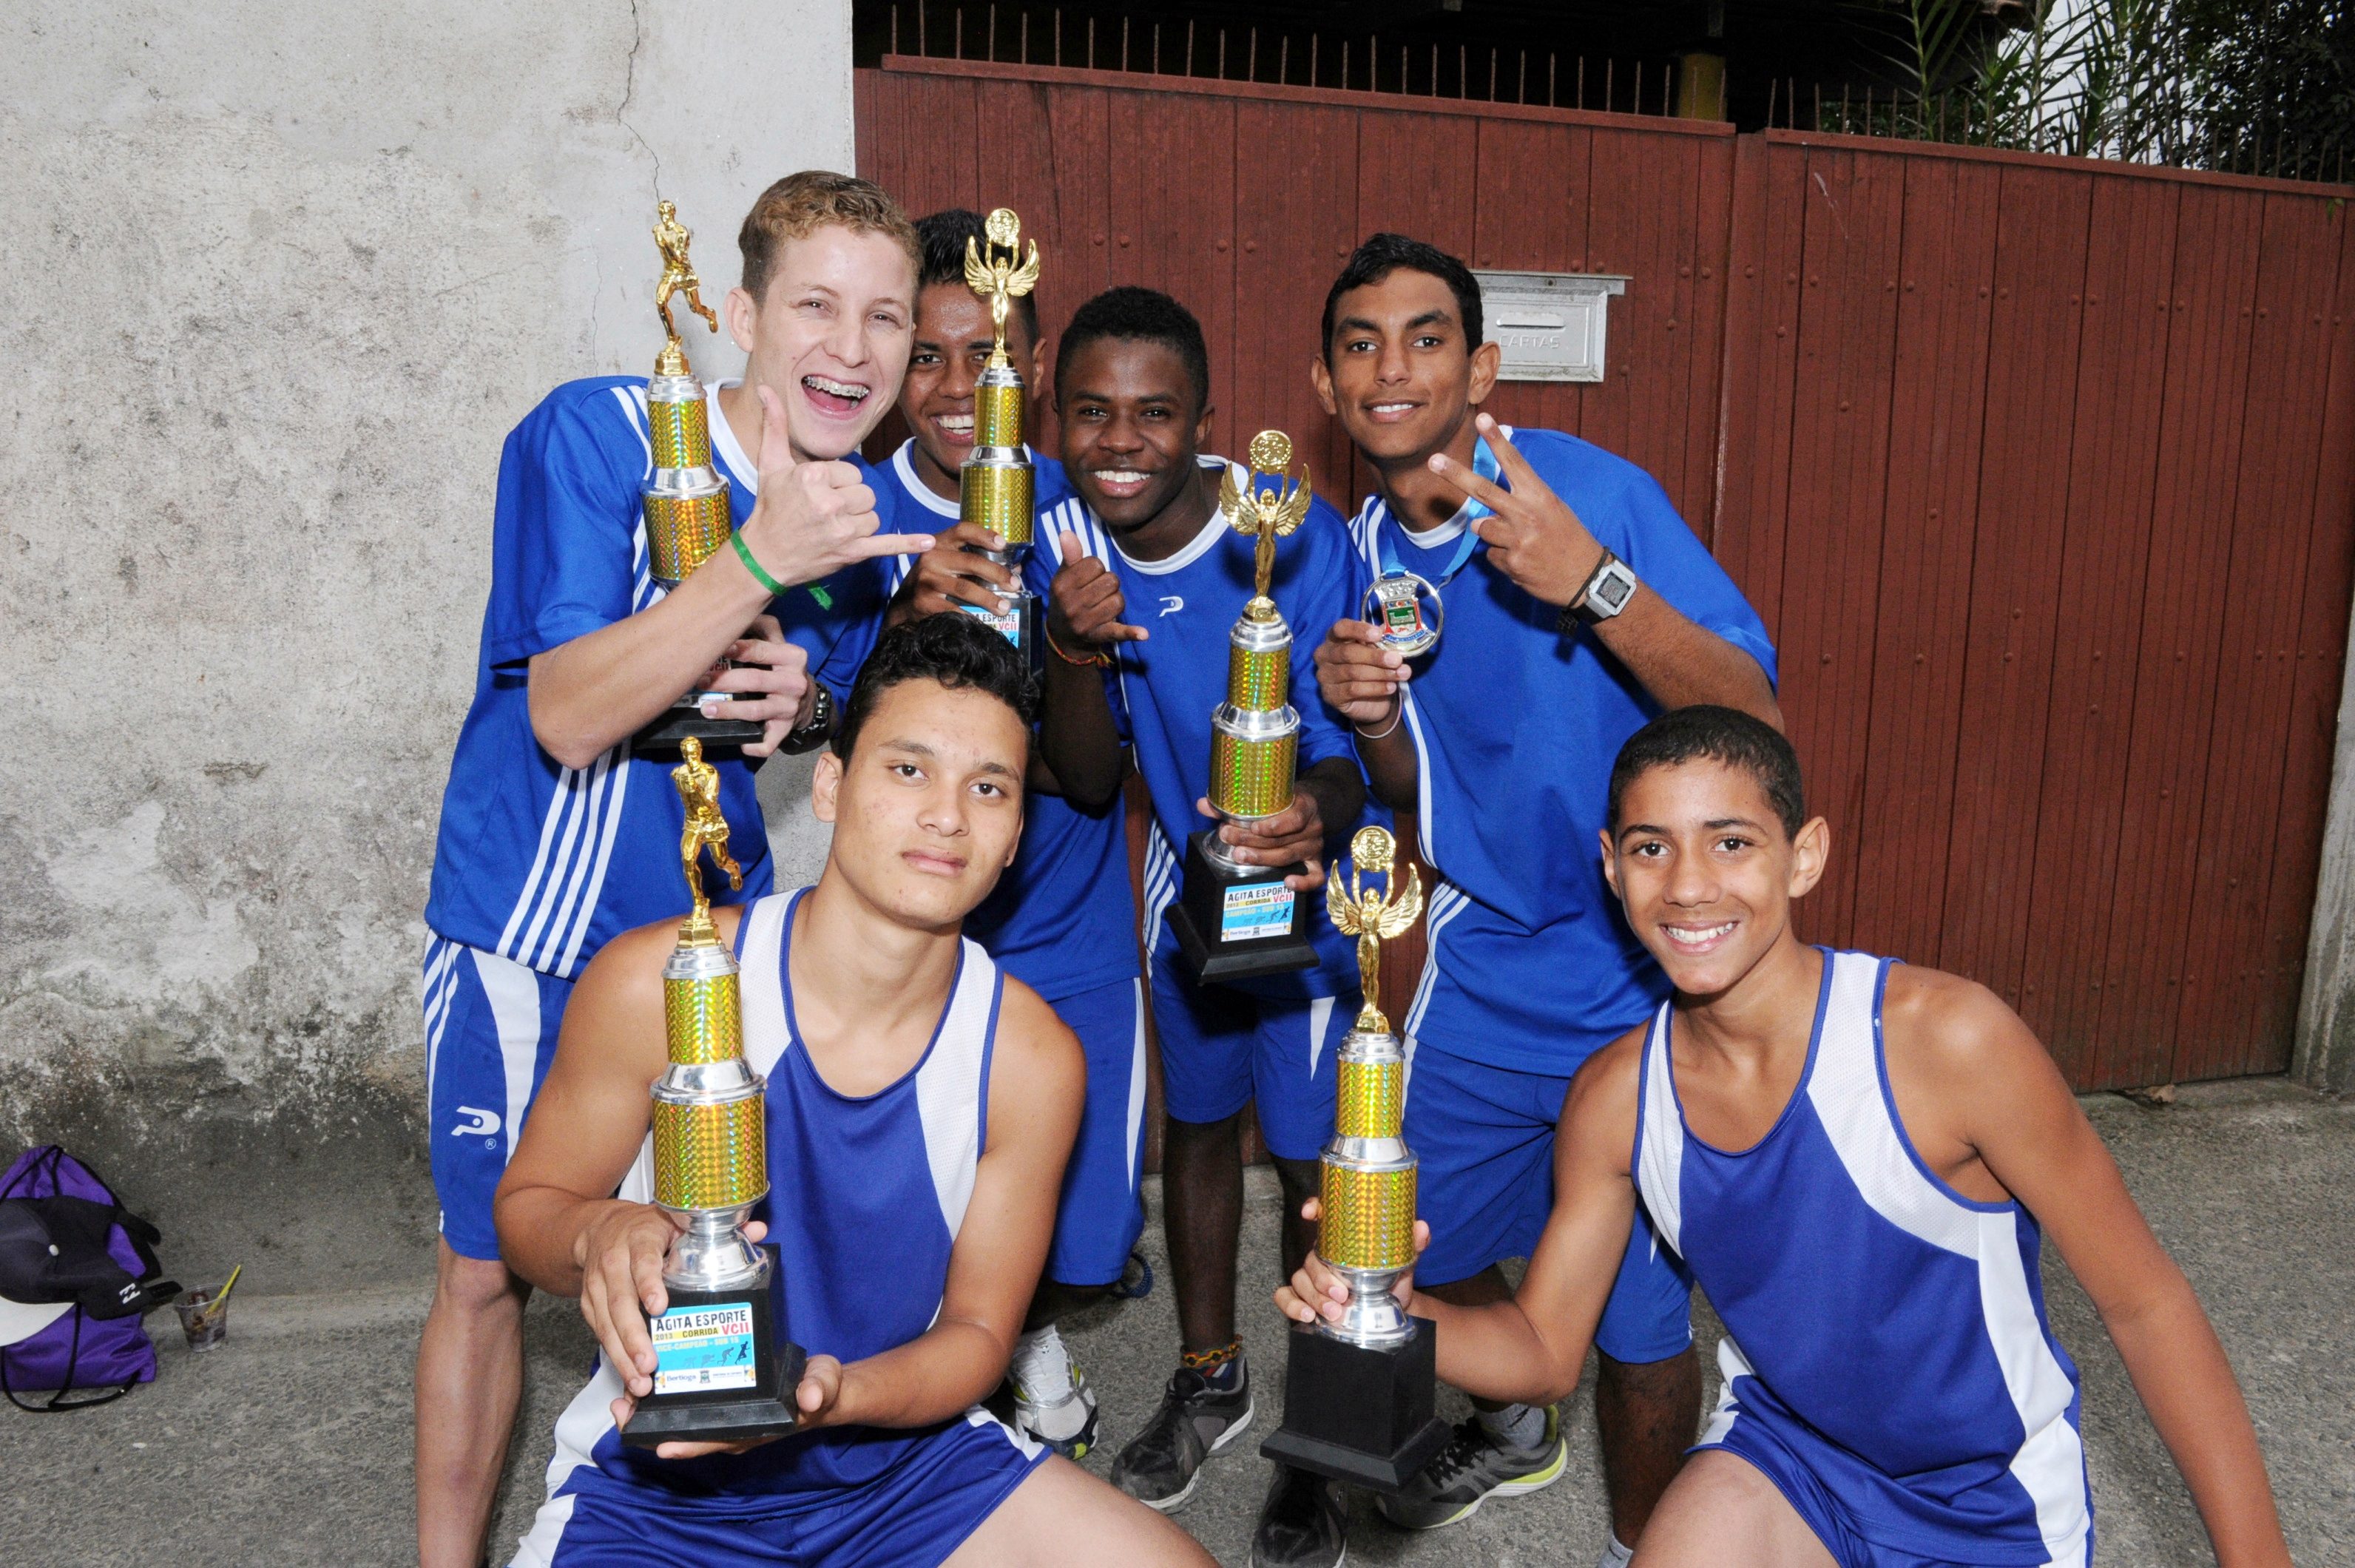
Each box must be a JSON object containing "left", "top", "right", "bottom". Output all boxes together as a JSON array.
[{"left": 1041, "top": 287, "right": 1366, "bottom": 1568}]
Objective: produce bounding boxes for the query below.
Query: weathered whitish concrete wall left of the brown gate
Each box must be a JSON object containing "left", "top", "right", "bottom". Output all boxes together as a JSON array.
[{"left": 0, "top": 0, "right": 853, "bottom": 1288}]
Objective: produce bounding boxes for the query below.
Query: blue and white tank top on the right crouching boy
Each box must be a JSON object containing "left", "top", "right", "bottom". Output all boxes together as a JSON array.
[{"left": 1635, "top": 951, "right": 2094, "bottom": 1568}]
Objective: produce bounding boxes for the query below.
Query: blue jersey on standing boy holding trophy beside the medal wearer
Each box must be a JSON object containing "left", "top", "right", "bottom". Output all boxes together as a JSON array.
[{"left": 1034, "top": 457, "right": 1390, "bottom": 998}]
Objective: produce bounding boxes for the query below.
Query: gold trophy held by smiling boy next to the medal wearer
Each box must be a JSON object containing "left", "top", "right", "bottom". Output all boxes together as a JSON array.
[{"left": 1170, "top": 431, "right": 1317, "bottom": 981}]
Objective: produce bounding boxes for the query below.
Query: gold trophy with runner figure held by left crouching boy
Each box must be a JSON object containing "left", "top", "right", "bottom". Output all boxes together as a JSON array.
[{"left": 622, "top": 734, "right": 808, "bottom": 1448}]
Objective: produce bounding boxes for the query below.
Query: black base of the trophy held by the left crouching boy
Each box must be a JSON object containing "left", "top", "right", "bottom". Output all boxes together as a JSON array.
[{"left": 622, "top": 1246, "right": 810, "bottom": 1448}]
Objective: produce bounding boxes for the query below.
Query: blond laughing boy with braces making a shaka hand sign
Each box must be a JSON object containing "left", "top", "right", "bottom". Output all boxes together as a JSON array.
[{"left": 417, "top": 169, "right": 930, "bottom": 1568}]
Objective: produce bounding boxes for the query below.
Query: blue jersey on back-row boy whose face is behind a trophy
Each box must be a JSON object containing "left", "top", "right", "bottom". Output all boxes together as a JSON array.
[{"left": 843, "top": 440, "right": 1138, "bottom": 1001}]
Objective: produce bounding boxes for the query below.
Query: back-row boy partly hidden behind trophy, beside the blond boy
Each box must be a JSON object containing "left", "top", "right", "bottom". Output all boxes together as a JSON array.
[{"left": 856, "top": 209, "right": 1152, "bottom": 1460}]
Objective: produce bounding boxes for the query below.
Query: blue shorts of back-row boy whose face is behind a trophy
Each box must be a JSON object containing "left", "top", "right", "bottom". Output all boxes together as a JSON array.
[{"left": 1046, "top": 979, "right": 1144, "bottom": 1285}]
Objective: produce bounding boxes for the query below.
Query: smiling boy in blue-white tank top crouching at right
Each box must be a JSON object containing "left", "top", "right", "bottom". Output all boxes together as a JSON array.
[{"left": 1277, "top": 706, "right": 2289, "bottom": 1568}]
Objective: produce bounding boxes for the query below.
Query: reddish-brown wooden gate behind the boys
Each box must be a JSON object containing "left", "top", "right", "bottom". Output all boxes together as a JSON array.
[{"left": 857, "top": 56, "right": 2355, "bottom": 1088}]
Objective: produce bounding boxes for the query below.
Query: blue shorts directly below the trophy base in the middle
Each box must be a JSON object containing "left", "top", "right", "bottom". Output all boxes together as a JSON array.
[{"left": 1152, "top": 923, "right": 1359, "bottom": 1160}]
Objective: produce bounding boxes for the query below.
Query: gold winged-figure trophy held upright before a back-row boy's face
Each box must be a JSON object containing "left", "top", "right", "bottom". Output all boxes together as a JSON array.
[{"left": 956, "top": 207, "right": 1041, "bottom": 659}]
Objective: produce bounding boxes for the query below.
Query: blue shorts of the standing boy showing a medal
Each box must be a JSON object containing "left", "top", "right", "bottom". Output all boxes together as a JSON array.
[{"left": 1406, "top": 1041, "right": 1693, "bottom": 1363}]
